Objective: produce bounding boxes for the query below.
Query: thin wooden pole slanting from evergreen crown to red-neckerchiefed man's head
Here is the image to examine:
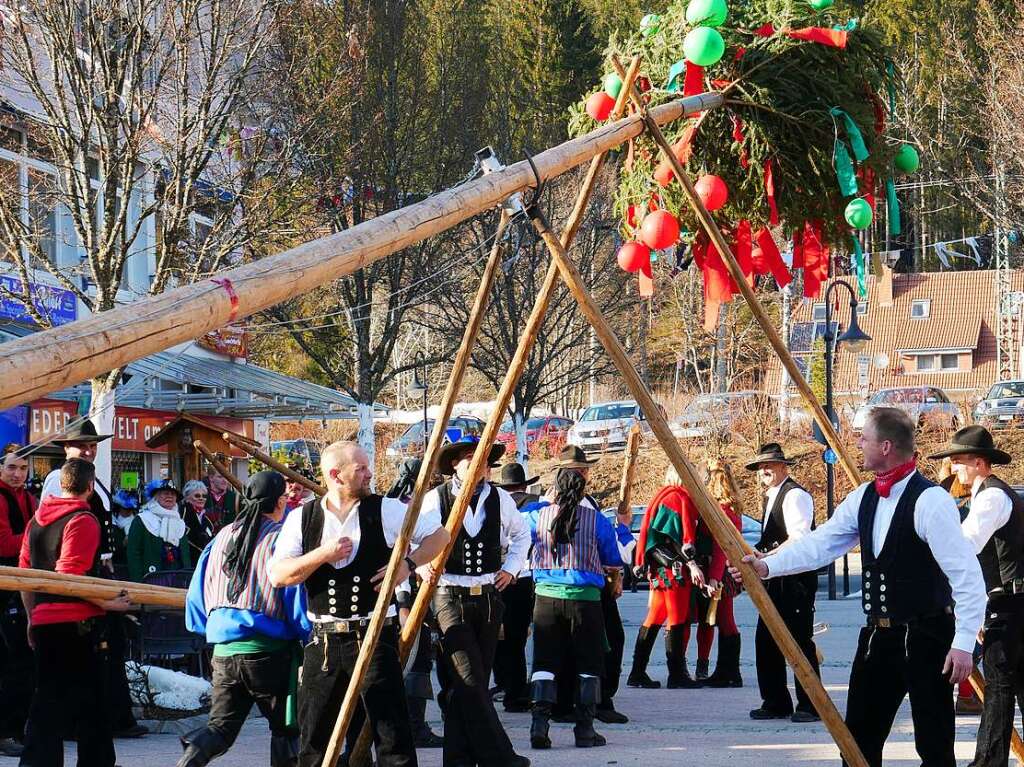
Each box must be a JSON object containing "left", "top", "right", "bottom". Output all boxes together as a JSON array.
[{"left": 612, "top": 55, "right": 860, "bottom": 487}]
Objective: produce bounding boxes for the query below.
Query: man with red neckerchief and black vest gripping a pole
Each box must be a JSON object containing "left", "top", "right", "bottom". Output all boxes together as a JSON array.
[{"left": 730, "top": 408, "right": 985, "bottom": 767}]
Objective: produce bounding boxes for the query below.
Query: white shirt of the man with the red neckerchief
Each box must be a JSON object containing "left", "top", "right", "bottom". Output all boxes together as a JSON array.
[{"left": 764, "top": 473, "right": 986, "bottom": 652}]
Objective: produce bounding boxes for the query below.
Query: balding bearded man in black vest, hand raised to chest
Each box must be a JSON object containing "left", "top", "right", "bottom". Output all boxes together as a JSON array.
[{"left": 270, "top": 441, "right": 449, "bottom": 767}]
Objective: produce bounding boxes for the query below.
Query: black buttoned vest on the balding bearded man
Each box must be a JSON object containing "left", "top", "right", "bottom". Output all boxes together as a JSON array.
[{"left": 301, "top": 496, "right": 391, "bottom": 620}]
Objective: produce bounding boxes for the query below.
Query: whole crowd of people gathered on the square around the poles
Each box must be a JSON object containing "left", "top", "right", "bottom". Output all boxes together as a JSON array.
[{"left": 6, "top": 408, "right": 1024, "bottom": 767}]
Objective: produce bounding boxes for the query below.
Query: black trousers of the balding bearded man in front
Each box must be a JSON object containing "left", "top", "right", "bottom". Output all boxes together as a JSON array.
[{"left": 299, "top": 625, "right": 417, "bottom": 767}]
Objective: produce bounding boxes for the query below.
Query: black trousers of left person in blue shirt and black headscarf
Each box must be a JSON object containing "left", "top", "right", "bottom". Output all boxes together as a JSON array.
[{"left": 206, "top": 649, "right": 298, "bottom": 745}]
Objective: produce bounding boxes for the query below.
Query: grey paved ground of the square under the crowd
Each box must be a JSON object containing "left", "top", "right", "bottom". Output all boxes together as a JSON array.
[{"left": 108, "top": 578, "right": 995, "bottom": 767}]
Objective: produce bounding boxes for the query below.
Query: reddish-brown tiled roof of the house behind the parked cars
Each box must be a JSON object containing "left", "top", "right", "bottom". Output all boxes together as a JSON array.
[{"left": 765, "top": 270, "right": 1024, "bottom": 394}]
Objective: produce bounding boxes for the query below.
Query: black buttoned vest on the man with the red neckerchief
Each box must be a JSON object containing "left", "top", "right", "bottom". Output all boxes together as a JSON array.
[{"left": 857, "top": 472, "right": 953, "bottom": 624}]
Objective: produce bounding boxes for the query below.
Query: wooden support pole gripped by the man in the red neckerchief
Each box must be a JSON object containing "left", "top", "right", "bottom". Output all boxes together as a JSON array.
[{"left": 529, "top": 201, "right": 867, "bottom": 767}]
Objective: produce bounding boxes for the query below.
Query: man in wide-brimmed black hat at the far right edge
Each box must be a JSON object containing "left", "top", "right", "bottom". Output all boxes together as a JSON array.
[{"left": 930, "top": 426, "right": 1024, "bottom": 767}]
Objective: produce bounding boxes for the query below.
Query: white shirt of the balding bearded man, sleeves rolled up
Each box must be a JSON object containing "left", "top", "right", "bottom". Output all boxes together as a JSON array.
[{"left": 270, "top": 498, "right": 441, "bottom": 622}]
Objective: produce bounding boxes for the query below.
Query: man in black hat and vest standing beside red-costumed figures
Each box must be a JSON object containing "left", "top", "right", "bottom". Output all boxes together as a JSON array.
[{"left": 746, "top": 442, "right": 818, "bottom": 722}]
